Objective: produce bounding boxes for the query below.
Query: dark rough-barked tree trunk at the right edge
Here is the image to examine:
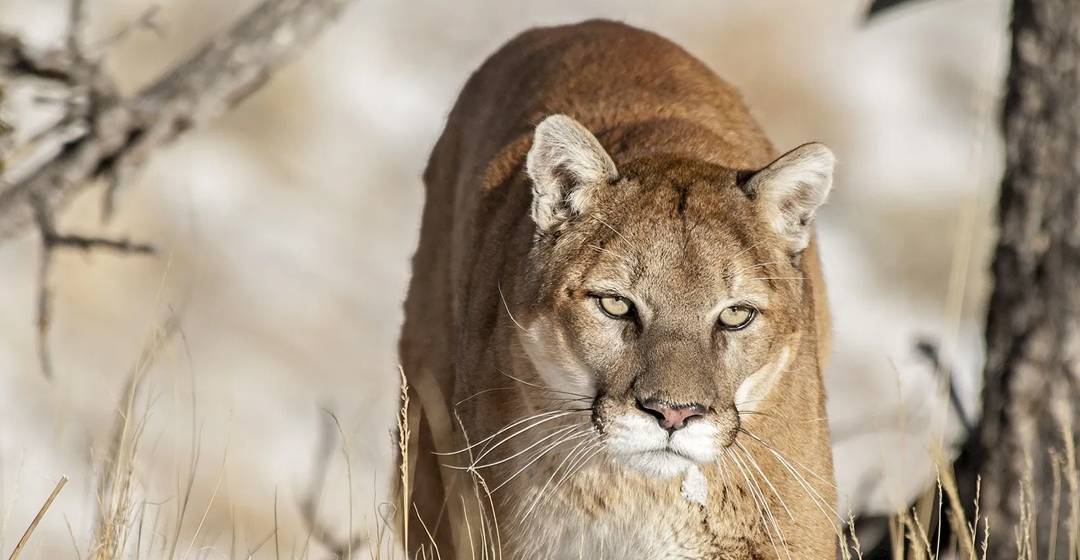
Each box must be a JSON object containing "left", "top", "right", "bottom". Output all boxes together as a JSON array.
[{"left": 957, "top": 0, "right": 1080, "bottom": 560}]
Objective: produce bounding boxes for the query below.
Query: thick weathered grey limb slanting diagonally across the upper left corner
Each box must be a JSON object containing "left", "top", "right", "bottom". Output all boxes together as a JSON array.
[{"left": 0, "top": 0, "right": 351, "bottom": 234}]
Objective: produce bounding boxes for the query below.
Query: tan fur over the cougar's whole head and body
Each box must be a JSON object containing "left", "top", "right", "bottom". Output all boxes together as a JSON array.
[{"left": 397, "top": 22, "right": 836, "bottom": 559}]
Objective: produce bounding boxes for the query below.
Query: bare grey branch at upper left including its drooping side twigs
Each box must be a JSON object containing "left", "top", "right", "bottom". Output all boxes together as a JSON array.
[{"left": 0, "top": 0, "right": 351, "bottom": 377}]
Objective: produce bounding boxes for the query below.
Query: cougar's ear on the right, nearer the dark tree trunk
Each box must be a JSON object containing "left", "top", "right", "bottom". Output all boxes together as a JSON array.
[{"left": 743, "top": 142, "right": 836, "bottom": 254}]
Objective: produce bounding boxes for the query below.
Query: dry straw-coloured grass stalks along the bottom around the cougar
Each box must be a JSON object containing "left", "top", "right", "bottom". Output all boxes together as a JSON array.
[{"left": 0, "top": 325, "right": 1080, "bottom": 560}]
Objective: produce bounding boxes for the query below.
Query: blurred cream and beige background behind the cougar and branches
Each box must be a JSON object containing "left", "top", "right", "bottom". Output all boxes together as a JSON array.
[{"left": 0, "top": 0, "right": 1008, "bottom": 558}]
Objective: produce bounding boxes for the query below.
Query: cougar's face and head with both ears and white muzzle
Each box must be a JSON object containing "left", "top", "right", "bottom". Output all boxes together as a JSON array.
[{"left": 521, "top": 117, "right": 833, "bottom": 477}]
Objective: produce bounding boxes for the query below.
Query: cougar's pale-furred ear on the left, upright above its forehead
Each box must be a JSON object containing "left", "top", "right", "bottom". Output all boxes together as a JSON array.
[{"left": 525, "top": 114, "right": 619, "bottom": 231}]
